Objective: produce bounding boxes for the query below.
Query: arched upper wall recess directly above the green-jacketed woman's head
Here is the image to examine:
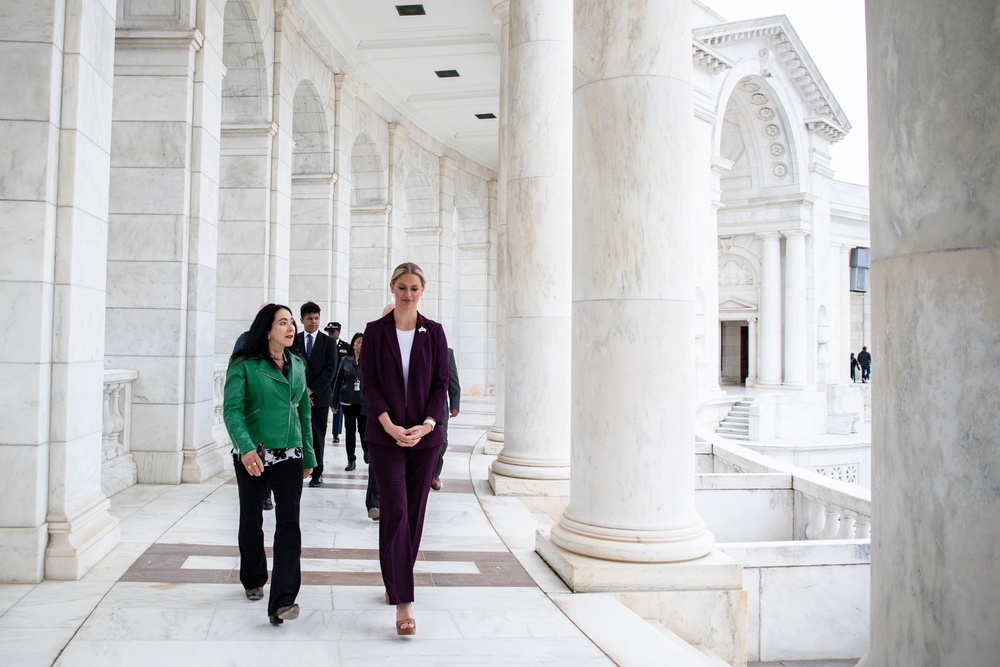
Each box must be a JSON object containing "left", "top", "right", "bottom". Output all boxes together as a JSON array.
[{"left": 222, "top": 0, "right": 271, "bottom": 123}]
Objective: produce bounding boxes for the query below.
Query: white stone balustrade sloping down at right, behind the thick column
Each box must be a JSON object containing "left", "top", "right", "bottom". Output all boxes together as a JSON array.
[{"left": 698, "top": 429, "right": 872, "bottom": 540}]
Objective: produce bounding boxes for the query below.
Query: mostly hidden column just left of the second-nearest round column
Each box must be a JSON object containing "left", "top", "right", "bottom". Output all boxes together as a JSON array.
[{"left": 485, "top": 0, "right": 510, "bottom": 454}]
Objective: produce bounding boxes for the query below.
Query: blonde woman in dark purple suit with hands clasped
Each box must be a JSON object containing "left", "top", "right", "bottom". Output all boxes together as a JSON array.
[{"left": 361, "top": 262, "right": 448, "bottom": 635}]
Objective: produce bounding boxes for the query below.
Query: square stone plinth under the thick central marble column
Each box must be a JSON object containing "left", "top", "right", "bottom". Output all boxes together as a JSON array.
[{"left": 535, "top": 529, "right": 748, "bottom": 667}]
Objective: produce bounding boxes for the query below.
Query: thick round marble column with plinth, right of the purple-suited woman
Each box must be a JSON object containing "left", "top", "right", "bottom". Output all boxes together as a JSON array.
[{"left": 535, "top": 0, "right": 747, "bottom": 665}]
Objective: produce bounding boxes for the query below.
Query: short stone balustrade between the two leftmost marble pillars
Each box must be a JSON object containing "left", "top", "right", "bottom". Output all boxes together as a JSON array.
[{"left": 101, "top": 369, "right": 139, "bottom": 496}]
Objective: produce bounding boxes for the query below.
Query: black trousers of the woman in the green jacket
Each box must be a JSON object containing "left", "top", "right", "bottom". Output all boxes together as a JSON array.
[{"left": 233, "top": 456, "right": 302, "bottom": 616}]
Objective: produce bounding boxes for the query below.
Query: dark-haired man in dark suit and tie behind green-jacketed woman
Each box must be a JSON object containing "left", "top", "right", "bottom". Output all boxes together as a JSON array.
[{"left": 294, "top": 301, "right": 339, "bottom": 487}]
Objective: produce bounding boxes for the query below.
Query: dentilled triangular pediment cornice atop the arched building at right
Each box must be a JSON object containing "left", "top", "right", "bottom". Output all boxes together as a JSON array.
[{"left": 693, "top": 15, "right": 851, "bottom": 143}]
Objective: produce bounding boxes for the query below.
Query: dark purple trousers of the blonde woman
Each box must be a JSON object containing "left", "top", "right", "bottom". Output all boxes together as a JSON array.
[{"left": 368, "top": 443, "right": 441, "bottom": 604}]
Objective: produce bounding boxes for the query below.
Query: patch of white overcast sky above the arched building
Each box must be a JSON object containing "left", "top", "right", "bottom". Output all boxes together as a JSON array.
[{"left": 702, "top": 0, "right": 868, "bottom": 185}]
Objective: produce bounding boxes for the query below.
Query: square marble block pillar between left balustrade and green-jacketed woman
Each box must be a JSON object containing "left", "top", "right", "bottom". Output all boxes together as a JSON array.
[{"left": 105, "top": 18, "right": 226, "bottom": 484}]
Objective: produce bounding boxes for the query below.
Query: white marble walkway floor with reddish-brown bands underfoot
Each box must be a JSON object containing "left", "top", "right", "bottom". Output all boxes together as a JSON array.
[{"left": 0, "top": 399, "right": 853, "bottom": 667}]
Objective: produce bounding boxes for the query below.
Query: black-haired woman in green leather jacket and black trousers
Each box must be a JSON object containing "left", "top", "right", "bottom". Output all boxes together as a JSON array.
[{"left": 223, "top": 303, "right": 316, "bottom": 625}]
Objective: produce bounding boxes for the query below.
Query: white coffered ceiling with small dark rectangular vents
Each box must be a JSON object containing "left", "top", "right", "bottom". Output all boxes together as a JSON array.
[{"left": 300, "top": 0, "right": 500, "bottom": 169}]
